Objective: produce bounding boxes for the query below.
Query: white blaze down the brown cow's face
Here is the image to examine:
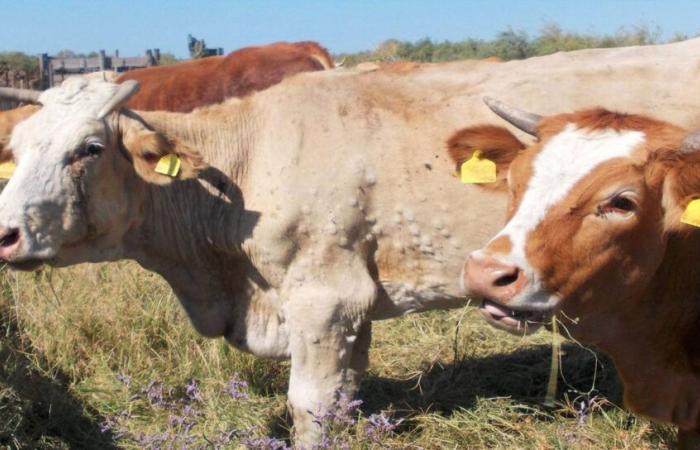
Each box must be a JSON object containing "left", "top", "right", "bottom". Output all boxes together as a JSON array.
[{"left": 494, "top": 124, "right": 645, "bottom": 296}]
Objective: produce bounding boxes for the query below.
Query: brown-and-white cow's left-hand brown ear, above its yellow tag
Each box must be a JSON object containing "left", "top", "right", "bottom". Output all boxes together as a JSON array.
[{"left": 447, "top": 125, "right": 525, "bottom": 189}]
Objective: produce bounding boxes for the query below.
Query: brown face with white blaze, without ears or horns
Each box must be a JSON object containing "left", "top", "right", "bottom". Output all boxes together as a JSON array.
[{"left": 463, "top": 110, "right": 683, "bottom": 333}]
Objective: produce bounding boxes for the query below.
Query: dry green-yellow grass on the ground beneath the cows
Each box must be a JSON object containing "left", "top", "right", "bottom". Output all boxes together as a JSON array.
[{"left": 0, "top": 262, "right": 675, "bottom": 449}]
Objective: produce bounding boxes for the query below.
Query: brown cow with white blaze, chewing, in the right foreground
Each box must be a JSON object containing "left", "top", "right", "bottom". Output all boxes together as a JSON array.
[{"left": 450, "top": 101, "right": 700, "bottom": 446}]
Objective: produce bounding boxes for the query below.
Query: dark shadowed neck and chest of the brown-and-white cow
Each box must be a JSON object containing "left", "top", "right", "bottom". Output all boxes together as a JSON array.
[{"left": 584, "top": 231, "right": 700, "bottom": 428}]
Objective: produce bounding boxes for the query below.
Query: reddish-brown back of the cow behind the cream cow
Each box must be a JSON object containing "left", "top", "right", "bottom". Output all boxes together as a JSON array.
[{"left": 117, "top": 41, "right": 333, "bottom": 112}]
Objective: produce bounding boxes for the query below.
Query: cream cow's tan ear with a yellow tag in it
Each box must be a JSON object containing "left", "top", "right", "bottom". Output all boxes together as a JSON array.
[{"left": 122, "top": 129, "right": 208, "bottom": 185}]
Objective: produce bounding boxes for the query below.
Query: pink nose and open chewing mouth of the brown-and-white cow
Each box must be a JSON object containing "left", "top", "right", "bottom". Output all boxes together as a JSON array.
[{"left": 463, "top": 252, "right": 550, "bottom": 334}]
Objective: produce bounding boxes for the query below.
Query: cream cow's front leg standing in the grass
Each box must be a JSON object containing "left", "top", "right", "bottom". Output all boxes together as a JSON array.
[{"left": 287, "top": 278, "right": 374, "bottom": 442}]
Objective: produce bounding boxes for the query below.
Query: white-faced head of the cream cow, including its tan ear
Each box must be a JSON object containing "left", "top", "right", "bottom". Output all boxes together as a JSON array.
[{"left": 0, "top": 78, "right": 204, "bottom": 269}]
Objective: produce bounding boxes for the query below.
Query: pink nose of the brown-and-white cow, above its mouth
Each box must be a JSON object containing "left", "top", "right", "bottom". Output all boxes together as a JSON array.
[{"left": 464, "top": 255, "right": 528, "bottom": 304}]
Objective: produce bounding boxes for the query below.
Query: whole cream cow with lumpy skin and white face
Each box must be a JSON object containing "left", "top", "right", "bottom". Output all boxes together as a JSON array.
[{"left": 0, "top": 40, "right": 700, "bottom": 443}]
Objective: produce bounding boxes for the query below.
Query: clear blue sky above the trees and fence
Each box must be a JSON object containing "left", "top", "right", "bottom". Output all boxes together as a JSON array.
[{"left": 0, "top": 0, "right": 700, "bottom": 57}]
